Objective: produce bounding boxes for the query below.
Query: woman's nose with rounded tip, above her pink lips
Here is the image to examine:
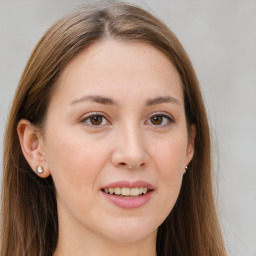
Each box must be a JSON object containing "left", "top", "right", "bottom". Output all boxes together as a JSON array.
[{"left": 112, "top": 125, "right": 149, "bottom": 169}]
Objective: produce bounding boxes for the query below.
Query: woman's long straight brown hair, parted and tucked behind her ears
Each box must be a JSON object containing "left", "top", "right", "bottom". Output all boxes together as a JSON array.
[{"left": 1, "top": 2, "right": 226, "bottom": 256}]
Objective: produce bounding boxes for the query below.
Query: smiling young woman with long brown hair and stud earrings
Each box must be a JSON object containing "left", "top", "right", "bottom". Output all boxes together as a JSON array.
[{"left": 1, "top": 2, "right": 226, "bottom": 256}]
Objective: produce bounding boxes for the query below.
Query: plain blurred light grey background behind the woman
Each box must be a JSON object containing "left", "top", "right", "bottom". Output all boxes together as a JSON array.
[{"left": 0, "top": 0, "right": 256, "bottom": 256}]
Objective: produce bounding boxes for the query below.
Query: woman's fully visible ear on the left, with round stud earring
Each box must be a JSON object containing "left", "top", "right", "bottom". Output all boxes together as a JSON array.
[{"left": 17, "top": 119, "right": 50, "bottom": 178}]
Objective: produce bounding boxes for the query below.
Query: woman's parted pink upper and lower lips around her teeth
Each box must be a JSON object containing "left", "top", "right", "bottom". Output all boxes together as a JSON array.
[{"left": 100, "top": 180, "right": 154, "bottom": 209}]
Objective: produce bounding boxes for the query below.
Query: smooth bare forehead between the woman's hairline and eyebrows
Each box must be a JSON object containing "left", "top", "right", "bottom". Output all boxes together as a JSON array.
[{"left": 53, "top": 40, "right": 183, "bottom": 107}]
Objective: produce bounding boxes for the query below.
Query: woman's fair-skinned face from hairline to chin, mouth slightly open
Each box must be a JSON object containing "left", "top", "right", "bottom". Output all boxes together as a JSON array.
[{"left": 43, "top": 40, "right": 193, "bottom": 242}]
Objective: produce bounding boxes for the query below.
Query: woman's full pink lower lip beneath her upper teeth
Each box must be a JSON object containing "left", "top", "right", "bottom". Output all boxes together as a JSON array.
[{"left": 101, "top": 191, "right": 153, "bottom": 209}]
